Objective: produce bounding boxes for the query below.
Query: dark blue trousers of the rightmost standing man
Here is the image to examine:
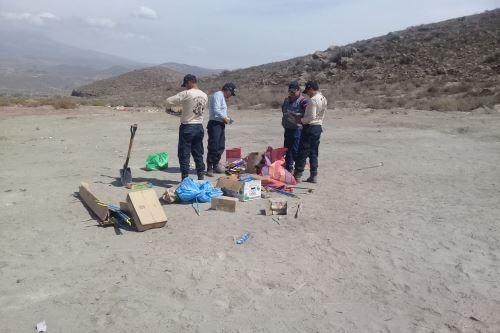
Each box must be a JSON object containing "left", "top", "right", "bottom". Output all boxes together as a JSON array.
[{"left": 295, "top": 125, "right": 323, "bottom": 176}]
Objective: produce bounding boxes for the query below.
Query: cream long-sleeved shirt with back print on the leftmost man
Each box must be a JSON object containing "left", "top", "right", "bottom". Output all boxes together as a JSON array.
[{"left": 167, "top": 88, "right": 208, "bottom": 124}]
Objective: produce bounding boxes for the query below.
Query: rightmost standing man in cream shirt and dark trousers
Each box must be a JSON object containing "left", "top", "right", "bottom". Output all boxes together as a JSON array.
[{"left": 294, "top": 81, "right": 327, "bottom": 183}]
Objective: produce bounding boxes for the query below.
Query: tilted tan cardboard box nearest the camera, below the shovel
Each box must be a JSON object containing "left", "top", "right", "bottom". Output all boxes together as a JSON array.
[{"left": 127, "top": 189, "right": 167, "bottom": 231}]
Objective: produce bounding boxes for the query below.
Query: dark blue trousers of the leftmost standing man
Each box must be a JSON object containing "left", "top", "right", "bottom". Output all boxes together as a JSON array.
[{"left": 177, "top": 124, "right": 205, "bottom": 178}]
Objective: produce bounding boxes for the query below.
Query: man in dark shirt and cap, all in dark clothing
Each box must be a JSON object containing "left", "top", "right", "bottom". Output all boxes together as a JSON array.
[{"left": 281, "top": 81, "right": 307, "bottom": 172}]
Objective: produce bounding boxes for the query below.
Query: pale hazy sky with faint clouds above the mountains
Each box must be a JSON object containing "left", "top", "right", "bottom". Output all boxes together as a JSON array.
[{"left": 0, "top": 0, "right": 500, "bottom": 69}]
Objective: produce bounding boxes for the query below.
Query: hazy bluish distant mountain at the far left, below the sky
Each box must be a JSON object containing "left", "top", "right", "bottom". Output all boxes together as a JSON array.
[{"left": 0, "top": 31, "right": 147, "bottom": 94}]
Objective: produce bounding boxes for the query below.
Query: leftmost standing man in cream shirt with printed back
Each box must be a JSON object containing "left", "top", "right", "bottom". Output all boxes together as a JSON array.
[{"left": 167, "top": 74, "right": 208, "bottom": 180}]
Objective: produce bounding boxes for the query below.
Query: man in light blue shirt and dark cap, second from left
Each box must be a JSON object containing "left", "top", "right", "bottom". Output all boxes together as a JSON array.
[{"left": 207, "top": 82, "right": 236, "bottom": 177}]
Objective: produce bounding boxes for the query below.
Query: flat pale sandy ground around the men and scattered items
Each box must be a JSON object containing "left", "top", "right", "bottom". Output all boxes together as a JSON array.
[{"left": 0, "top": 107, "right": 500, "bottom": 332}]
